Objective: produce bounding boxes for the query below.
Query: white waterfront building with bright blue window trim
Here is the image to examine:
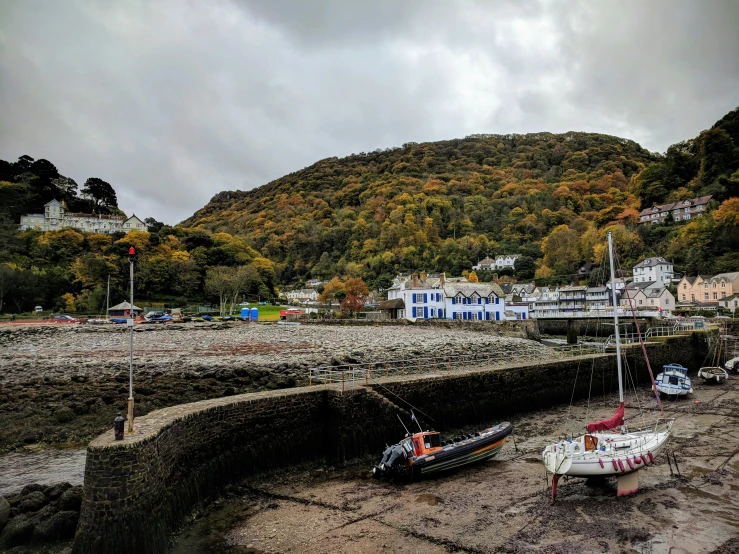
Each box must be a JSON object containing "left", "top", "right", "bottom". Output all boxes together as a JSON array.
[{"left": 387, "top": 274, "right": 529, "bottom": 321}]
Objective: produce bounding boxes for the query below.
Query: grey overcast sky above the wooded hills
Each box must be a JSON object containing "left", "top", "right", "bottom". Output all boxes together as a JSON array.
[{"left": 0, "top": 0, "right": 739, "bottom": 223}]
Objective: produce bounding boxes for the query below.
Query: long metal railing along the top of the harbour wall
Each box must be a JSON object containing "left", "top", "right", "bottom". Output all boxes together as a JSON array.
[{"left": 308, "top": 344, "right": 603, "bottom": 391}]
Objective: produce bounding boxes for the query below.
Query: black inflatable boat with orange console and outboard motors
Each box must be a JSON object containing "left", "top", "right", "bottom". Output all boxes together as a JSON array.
[{"left": 372, "top": 421, "right": 513, "bottom": 479}]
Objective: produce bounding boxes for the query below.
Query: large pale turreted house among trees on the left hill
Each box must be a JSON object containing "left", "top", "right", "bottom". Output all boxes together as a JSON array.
[{"left": 20, "top": 200, "right": 147, "bottom": 235}]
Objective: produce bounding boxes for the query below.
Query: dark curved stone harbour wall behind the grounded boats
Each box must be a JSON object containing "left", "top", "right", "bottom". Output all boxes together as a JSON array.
[{"left": 74, "top": 335, "right": 706, "bottom": 554}]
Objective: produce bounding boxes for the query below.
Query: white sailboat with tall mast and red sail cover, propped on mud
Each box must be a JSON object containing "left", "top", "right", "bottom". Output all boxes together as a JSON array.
[{"left": 542, "top": 232, "right": 674, "bottom": 499}]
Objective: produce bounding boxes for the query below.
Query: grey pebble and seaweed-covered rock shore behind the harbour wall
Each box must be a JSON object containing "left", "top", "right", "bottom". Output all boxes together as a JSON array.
[{"left": 0, "top": 324, "right": 551, "bottom": 452}]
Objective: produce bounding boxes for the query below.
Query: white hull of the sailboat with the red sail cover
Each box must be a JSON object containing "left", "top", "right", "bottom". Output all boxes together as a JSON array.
[{"left": 542, "top": 420, "right": 672, "bottom": 477}]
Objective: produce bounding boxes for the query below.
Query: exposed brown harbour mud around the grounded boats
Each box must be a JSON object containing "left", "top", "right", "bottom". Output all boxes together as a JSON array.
[{"left": 173, "top": 375, "right": 739, "bottom": 554}]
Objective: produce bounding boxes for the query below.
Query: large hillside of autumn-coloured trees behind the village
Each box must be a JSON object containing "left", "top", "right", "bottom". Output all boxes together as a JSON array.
[{"left": 182, "top": 106, "right": 739, "bottom": 286}]
